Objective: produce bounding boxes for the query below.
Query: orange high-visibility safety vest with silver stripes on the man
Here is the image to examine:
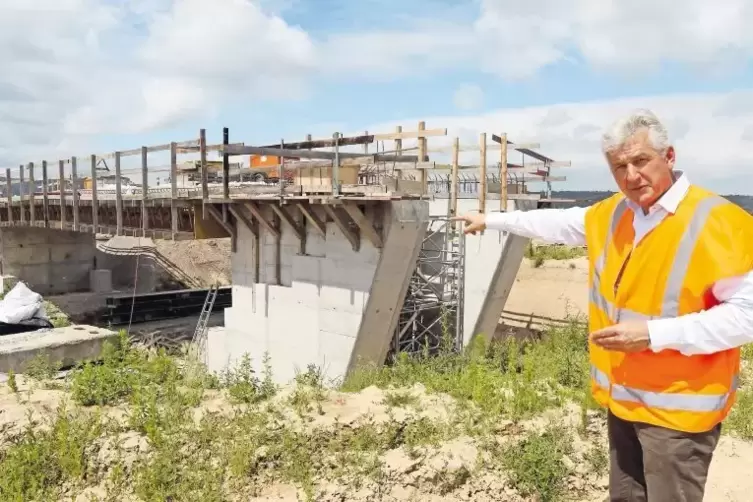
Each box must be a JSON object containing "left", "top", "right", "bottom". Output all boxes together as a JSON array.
[{"left": 586, "top": 185, "right": 753, "bottom": 432}]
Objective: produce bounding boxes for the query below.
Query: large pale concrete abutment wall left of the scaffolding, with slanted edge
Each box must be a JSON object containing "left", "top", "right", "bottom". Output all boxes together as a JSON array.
[{"left": 206, "top": 201, "right": 428, "bottom": 382}]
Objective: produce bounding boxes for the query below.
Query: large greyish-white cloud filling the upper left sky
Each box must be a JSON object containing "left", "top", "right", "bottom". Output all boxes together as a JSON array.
[{"left": 0, "top": 0, "right": 316, "bottom": 165}]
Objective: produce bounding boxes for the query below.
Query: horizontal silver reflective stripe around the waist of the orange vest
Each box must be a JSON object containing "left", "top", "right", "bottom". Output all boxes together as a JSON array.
[{"left": 591, "top": 365, "right": 739, "bottom": 412}]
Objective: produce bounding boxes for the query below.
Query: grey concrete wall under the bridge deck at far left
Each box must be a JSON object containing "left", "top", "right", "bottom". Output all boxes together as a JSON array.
[{"left": 0, "top": 227, "right": 96, "bottom": 295}]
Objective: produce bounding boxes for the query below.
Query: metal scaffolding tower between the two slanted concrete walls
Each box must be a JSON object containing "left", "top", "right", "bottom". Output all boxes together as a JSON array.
[{"left": 388, "top": 217, "right": 465, "bottom": 361}]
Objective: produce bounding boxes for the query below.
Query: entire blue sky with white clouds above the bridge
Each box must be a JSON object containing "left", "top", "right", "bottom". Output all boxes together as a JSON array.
[{"left": 0, "top": 0, "right": 753, "bottom": 194}]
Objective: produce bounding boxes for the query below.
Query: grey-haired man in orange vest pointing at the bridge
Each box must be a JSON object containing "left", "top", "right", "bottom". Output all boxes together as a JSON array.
[{"left": 456, "top": 110, "right": 753, "bottom": 502}]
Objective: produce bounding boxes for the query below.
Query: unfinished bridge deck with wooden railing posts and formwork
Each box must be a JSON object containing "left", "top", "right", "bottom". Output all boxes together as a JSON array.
[{"left": 0, "top": 122, "right": 563, "bottom": 240}]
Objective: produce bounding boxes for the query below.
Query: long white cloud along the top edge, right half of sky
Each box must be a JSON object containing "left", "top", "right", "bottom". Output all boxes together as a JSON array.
[{"left": 331, "top": 0, "right": 753, "bottom": 80}]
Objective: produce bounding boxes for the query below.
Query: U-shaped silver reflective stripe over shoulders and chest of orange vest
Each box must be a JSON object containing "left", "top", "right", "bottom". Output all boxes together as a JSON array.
[{"left": 589, "top": 196, "right": 730, "bottom": 323}]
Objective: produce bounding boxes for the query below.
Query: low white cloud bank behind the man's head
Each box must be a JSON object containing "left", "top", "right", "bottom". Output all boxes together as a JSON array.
[{"left": 356, "top": 91, "right": 753, "bottom": 192}]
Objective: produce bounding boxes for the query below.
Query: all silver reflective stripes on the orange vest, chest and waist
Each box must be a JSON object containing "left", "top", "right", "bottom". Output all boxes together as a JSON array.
[{"left": 589, "top": 196, "right": 739, "bottom": 412}]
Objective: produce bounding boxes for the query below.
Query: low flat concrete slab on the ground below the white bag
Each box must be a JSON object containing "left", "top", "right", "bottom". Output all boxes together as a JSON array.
[{"left": 0, "top": 325, "right": 117, "bottom": 373}]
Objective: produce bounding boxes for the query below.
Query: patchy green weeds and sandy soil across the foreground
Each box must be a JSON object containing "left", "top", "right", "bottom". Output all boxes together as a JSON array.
[{"left": 0, "top": 320, "right": 753, "bottom": 502}]
